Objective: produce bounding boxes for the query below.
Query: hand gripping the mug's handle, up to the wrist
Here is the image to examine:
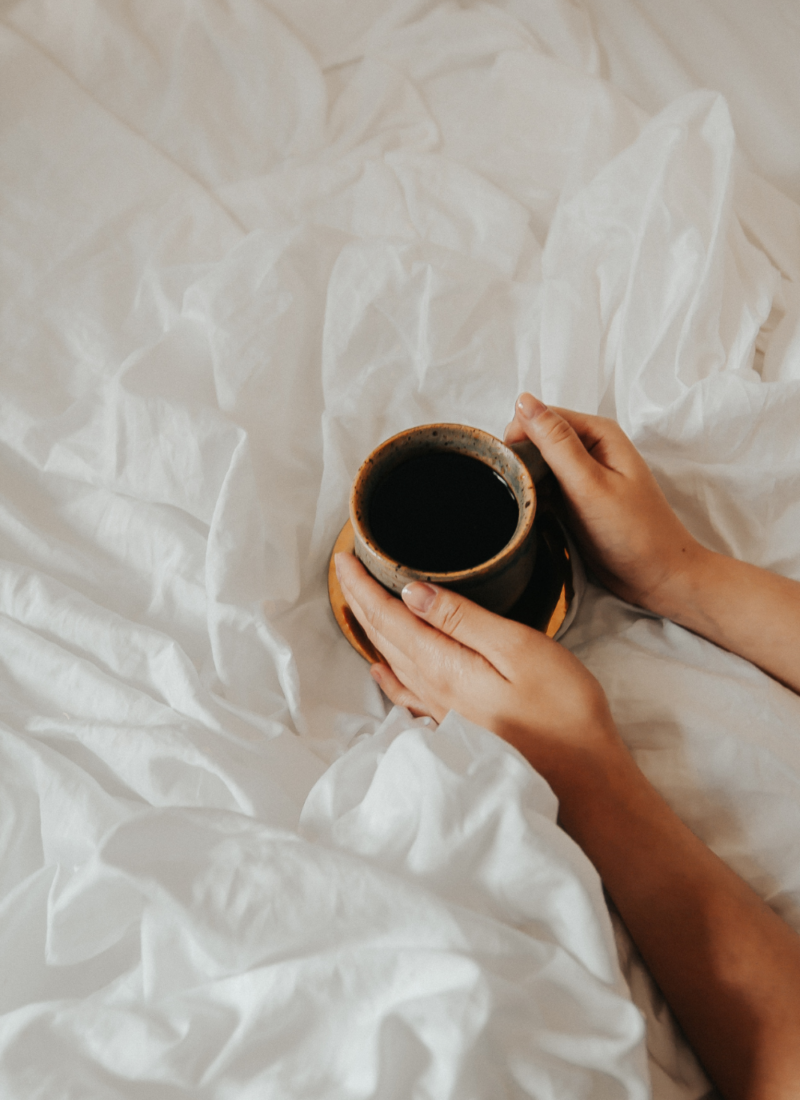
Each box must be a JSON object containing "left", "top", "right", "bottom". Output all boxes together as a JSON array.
[{"left": 505, "top": 394, "right": 705, "bottom": 613}]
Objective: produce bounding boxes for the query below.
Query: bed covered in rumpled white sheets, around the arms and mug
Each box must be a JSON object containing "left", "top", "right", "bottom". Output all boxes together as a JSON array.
[{"left": 0, "top": 0, "right": 800, "bottom": 1100}]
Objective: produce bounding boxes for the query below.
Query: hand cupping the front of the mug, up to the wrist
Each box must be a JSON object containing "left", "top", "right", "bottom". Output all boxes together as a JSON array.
[{"left": 336, "top": 554, "right": 627, "bottom": 800}]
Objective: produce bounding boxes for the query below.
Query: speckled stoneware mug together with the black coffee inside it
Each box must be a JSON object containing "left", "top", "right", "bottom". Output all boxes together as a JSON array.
[{"left": 350, "top": 424, "right": 548, "bottom": 615}]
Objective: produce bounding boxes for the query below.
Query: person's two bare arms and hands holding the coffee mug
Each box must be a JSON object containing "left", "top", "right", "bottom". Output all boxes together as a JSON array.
[{"left": 337, "top": 394, "right": 800, "bottom": 1100}]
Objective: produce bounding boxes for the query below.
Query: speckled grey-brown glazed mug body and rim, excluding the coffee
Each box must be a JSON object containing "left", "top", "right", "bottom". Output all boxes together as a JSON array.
[{"left": 350, "top": 424, "right": 547, "bottom": 615}]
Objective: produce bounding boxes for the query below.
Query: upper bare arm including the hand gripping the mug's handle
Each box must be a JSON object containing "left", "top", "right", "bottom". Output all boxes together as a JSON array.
[{"left": 506, "top": 394, "right": 800, "bottom": 692}]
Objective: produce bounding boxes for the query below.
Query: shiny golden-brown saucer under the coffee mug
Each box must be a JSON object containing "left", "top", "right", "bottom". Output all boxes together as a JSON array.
[{"left": 328, "top": 497, "right": 576, "bottom": 664}]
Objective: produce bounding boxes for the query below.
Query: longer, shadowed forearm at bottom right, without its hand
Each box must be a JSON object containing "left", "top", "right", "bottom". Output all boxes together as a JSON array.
[{"left": 557, "top": 757, "right": 800, "bottom": 1100}]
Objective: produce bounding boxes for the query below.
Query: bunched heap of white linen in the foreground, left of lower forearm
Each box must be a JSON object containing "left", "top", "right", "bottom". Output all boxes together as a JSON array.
[{"left": 0, "top": 711, "right": 648, "bottom": 1098}]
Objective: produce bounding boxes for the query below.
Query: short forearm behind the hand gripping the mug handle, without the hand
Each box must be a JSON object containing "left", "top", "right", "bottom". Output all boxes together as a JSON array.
[{"left": 650, "top": 547, "right": 800, "bottom": 693}]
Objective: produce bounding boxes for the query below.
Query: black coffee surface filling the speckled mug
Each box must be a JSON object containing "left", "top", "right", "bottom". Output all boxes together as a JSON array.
[{"left": 369, "top": 451, "right": 519, "bottom": 573}]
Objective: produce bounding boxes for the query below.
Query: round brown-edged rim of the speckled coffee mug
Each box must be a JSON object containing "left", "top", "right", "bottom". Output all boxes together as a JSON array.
[{"left": 350, "top": 421, "right": 537, "bottom": 585}]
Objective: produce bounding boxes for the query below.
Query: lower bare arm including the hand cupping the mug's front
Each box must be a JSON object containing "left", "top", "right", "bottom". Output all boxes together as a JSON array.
[{"left": 337, "top": 554, "right": 800, "bottom": 1100}]
